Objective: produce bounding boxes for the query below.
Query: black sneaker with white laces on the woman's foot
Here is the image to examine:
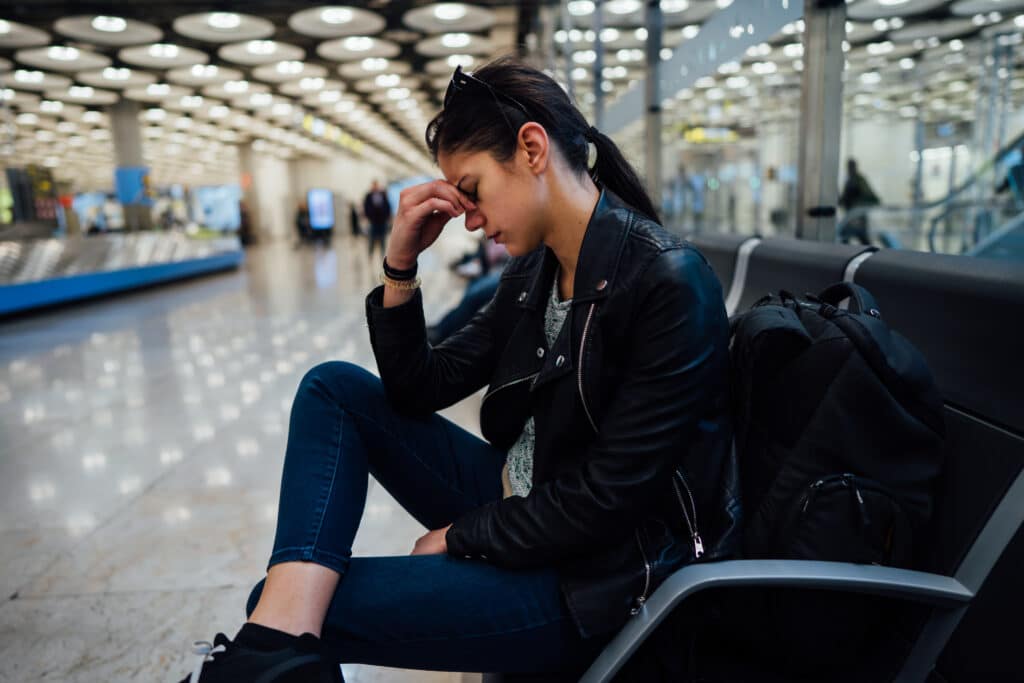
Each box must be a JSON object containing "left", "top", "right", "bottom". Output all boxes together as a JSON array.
[{"left": 180, "top": 633, "right": 344, "bottom": 683}]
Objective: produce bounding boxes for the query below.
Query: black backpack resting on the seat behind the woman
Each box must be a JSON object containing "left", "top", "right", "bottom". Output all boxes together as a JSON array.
[{"left": 731, "top": 283, "right": 944, "bottom": 676}]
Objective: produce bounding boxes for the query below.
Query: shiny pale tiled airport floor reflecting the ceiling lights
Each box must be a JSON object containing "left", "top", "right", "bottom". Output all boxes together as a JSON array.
[{"left": 0, "top": 235, "right": 479, "bottom": 683}]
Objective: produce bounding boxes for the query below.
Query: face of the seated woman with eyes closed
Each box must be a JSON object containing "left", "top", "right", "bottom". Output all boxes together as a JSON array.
[{"left": 437, "top": 143, "right": 545, "bottom": 256}]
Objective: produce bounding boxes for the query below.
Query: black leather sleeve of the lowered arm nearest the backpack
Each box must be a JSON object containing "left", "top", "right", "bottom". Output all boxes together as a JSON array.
[{"left": 445, "top": 249, "right": 728, "bottom": 568}]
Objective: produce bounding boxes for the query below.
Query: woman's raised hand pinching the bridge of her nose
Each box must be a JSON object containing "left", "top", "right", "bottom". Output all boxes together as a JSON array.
[{"left": 387, "top": 180, "right": 476, "bottom": 270}]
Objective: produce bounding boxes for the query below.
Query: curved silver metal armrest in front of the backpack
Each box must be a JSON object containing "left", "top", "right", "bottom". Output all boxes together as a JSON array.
[{"left": 580, "top": 560, "right": 974, "bottom": 683}]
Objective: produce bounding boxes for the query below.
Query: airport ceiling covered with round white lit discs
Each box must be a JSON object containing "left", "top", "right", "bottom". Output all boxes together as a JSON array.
[{"left": 0, "top": 0, "right": 1024, "bottom": 189}]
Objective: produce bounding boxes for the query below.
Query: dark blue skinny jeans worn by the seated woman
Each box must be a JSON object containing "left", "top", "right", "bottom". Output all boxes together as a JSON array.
[{"left": 249, "top": 362, "right": 604, "bottom": 675}]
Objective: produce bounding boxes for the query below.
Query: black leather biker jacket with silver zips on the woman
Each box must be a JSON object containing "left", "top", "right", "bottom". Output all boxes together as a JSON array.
[{"left": 367, "top": 190, "right": 739, "bottom": 637}]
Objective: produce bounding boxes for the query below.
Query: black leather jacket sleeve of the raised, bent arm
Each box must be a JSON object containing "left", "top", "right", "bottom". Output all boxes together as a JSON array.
[{"left": 367, "top": 276, "right": 509, "bottom": 417}]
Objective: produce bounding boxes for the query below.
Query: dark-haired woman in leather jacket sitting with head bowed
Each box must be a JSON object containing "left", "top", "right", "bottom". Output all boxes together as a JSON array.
[{"left": 182, "top": 58, "right": 735, "bottom": 683}]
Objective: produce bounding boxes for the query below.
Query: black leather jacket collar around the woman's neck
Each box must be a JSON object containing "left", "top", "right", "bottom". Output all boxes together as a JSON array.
[{"left": 520, "top": 189, "right": 633, "bottom": 310}]
